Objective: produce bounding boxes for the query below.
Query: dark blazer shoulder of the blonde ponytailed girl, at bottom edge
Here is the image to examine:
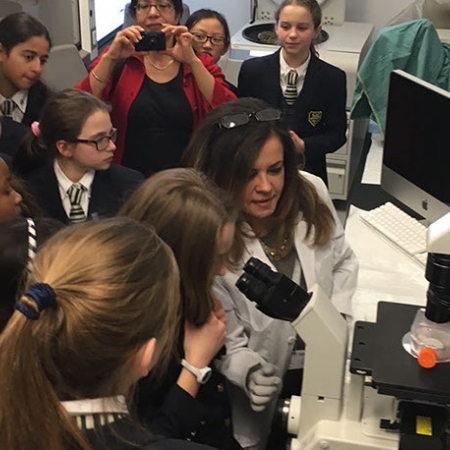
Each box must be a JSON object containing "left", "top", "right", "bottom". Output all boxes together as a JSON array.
[{"left": 84, "top": 419, "right": 218, "bottom": 450}]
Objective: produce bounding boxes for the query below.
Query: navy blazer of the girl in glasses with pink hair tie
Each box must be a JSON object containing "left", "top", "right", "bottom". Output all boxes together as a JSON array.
[{"left": 25, "top": 162, "right": 144, "bottom": 224}]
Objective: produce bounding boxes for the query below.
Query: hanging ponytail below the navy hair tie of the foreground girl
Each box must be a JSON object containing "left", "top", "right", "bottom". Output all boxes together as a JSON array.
[{"left": 0, "top": 297, "right": 91, "bottom": 450}]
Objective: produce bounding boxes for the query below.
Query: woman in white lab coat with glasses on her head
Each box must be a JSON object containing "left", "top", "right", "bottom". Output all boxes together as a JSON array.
[{"left": 181, "top": 98, "right": 358, "bottom": 450}]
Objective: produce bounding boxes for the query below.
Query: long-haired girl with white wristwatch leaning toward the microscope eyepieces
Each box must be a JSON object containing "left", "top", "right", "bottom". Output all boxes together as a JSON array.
[{"left": 119, "top": 169, "right": 241, "bottom": 450}]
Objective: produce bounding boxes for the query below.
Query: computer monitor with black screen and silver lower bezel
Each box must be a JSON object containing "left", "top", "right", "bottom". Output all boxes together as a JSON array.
[{"left": 381, "top": 70, "right": 450, "bottom": 223}]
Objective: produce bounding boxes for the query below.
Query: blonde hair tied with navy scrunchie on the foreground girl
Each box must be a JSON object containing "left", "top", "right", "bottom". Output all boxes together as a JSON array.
[{"left": 0, "top": 218, "right": 179, "bottom": 450}]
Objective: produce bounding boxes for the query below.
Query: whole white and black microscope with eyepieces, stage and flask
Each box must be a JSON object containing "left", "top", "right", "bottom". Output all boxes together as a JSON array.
[{"left": 236, "top": 213, "right": 450, "bottom": 450}]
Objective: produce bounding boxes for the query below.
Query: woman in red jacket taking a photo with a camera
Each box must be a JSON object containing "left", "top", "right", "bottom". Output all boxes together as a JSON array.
[{"left": 77, "top": 0, "right": 235, "bottom": 175}]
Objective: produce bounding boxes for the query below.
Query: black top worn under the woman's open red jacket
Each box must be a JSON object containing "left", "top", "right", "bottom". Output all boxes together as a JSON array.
[{"left": 122, "top": 67, "right": 193, "bottom": 176}]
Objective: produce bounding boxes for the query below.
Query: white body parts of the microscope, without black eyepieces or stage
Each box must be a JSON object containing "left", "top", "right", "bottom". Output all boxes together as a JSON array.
[{"left": 288, "top": 213, "right": 450, "bottom": 450}]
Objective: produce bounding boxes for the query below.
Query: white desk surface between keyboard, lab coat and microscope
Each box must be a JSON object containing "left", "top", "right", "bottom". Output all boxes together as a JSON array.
[{"left": 345, "top": 205, "right": 428, "bottom": 322}]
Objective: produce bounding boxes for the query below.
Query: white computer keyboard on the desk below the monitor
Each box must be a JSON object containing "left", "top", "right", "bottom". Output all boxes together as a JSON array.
[{"left": 361, "top": 202, "right": 427, "bottom": 267}]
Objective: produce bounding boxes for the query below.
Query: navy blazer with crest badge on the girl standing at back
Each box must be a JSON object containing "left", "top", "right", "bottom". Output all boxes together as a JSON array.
[{"left": 238, "top": 50, "right": 347, "bottom": 183}]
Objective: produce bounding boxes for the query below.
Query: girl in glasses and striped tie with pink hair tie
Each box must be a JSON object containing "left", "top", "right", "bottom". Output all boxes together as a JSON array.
[{"left": 13, "top": 89, "right": 143, "bottom": 223}]
